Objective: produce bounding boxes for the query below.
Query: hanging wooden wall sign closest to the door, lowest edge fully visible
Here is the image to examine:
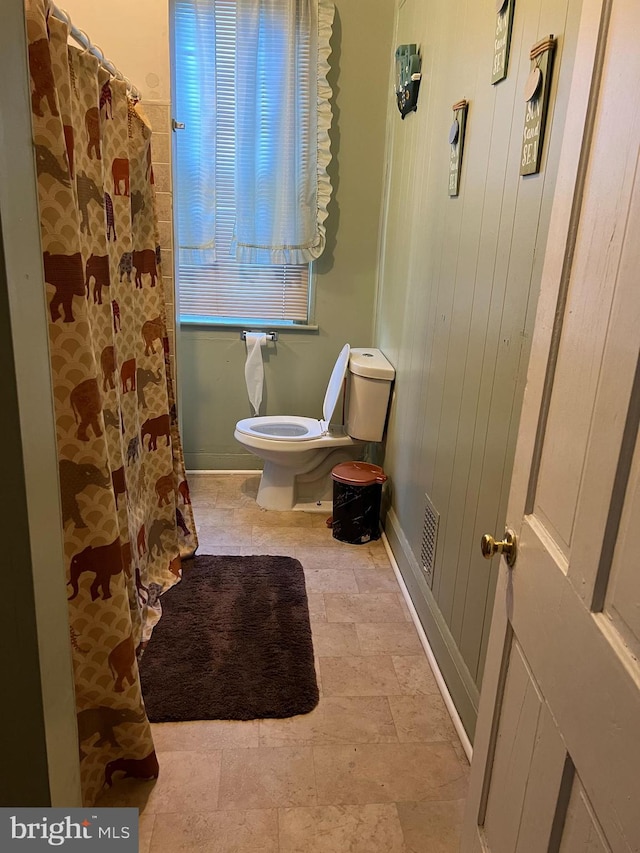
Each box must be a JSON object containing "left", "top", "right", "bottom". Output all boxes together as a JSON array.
[{"left": 520, "top": 35, "right": 556, "bottom": 175}]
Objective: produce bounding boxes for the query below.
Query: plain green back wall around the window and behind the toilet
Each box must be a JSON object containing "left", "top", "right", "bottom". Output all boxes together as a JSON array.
[{"left": 178, "top": 0, "right": 395, "bottom": 469}]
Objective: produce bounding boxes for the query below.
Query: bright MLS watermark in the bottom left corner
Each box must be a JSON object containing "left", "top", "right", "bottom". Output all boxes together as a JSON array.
[{"left": 0, "top": 808, "right": 138, "bottom": 853}]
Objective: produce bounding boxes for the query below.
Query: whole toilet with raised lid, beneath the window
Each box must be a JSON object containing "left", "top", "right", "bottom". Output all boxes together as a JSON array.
[{"left": 234, "top": 344, "right": 395, "bottom": 510}]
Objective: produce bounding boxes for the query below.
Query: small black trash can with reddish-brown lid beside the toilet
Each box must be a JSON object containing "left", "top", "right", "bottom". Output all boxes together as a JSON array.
[{"left": 331, "top": 462, "right": 387, "bottom": 545}]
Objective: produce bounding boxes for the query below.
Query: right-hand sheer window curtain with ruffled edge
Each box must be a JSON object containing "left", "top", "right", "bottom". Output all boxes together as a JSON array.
[{"left": 234, "top": 0, "right": 334, "bottom": 264}]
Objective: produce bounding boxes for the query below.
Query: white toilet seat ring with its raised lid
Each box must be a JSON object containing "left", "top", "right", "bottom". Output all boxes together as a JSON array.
[{"left": 236, "top": 344, "right": 351, "bottom": 442}]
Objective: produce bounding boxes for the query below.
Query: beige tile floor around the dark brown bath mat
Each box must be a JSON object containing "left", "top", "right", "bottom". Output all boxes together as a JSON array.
[{"left": 98, "top": 474, "right": 469, "bottom": 853}]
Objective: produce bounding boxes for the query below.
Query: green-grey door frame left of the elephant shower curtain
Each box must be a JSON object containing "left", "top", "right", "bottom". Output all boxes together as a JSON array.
[{"left": 0, "top": 0, "right": 82, "bottom": 808}]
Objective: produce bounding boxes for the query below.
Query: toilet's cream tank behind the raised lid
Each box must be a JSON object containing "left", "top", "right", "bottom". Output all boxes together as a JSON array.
[{"left": 347, "top": 347, "right": 396, "bottom": 441}]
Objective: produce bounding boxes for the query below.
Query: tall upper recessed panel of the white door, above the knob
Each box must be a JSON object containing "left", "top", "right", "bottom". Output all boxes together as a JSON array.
[{"left": 535, "top": 21, "right": 640, "bottom": 556}]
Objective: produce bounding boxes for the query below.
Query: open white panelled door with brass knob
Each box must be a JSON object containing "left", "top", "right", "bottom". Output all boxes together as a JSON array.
[{"left": 462, "top": 0, "right": 640, "bottom": 853}]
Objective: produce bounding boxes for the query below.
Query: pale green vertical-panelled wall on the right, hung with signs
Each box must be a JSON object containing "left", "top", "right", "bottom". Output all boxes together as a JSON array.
[{"left": 375, "top": 0, "right": 581, "bottom": 735}]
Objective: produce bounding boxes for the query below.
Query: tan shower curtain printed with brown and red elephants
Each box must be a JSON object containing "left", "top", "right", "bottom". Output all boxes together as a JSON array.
[{"left": 26, "top": 0, "right": 197, "bottom": 804}]
